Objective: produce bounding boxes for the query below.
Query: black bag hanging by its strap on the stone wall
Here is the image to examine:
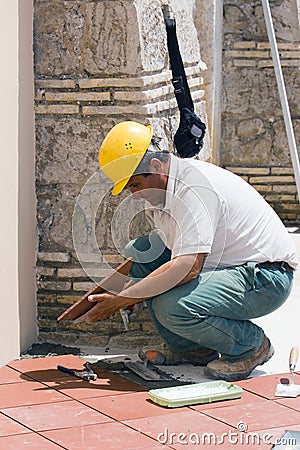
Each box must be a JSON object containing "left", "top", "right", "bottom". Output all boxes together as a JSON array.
[{"left": 162, "top": 5, "right": 206, "bottom": 158}]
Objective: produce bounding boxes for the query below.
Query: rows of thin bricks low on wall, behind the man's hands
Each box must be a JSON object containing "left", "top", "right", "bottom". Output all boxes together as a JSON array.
[{"left": 37, "top": 252, "right": 159, "bottom": 349}]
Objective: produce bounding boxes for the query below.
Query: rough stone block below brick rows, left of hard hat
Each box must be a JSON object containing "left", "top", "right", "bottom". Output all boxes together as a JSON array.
[{"left": 36, "top": 115, "right": 101, "bottom": 186}]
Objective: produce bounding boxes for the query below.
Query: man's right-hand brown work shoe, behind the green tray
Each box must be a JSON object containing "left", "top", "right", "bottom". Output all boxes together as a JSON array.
[{"left": 204, "top": 336, "right": 274, "bottom": 381}]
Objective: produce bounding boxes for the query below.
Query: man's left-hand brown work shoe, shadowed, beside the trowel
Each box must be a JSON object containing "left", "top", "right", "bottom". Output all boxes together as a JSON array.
[{"left": 139, "top": 344, "right": 219, "bottom": 366}]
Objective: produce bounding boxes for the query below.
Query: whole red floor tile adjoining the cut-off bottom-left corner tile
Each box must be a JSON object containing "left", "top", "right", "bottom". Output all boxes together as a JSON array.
[{"left": 2, "top": 400, "right": 112, "bottom": 431}]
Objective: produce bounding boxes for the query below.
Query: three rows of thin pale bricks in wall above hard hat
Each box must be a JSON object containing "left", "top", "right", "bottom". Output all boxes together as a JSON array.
[{"left": 35, "top": 66, "right": 204, "bottom": 118}]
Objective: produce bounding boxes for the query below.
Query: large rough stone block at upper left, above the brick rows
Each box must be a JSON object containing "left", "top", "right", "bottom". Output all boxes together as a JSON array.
[{"left": 35, "top": 0, "right": 139, "bottom": 77}]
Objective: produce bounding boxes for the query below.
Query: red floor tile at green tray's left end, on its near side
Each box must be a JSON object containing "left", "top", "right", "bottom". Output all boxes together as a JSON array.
[{"left": 82, "top": 392, "right": 188, "bottom": 420}]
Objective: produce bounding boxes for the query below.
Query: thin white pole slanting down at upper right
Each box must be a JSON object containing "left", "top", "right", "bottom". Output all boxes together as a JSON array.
[{"left": 262, "top": 0, "right": 300, "bottom": 201}]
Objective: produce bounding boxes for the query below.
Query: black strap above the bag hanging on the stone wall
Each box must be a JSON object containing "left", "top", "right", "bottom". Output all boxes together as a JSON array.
[{"left": 165, "top": 18, "right": 194, "bottom": 111}]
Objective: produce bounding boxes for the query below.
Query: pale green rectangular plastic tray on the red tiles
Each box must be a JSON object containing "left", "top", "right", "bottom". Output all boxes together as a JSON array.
[{"left": 149, "top": 381, "right": 243, "bottom": 408}]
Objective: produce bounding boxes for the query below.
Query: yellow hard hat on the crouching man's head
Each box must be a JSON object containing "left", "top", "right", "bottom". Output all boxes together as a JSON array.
[{"left": 98, "top": 121, "right": 153, "bottom": 195}]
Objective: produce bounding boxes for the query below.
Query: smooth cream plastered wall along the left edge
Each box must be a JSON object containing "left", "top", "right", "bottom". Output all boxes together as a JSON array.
[{"left": 0, "top": 0, "right": 37, "bottom": 367}]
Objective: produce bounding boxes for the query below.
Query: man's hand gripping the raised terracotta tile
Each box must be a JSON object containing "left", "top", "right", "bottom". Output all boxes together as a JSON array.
[{"left": 74, "top": 292, "right": 128, "bottom": 323}]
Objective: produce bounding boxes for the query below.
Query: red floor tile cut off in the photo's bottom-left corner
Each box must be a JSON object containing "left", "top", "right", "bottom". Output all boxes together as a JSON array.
[{"left": 0, "top": 433, "right": 61, "bottom": 450}]
